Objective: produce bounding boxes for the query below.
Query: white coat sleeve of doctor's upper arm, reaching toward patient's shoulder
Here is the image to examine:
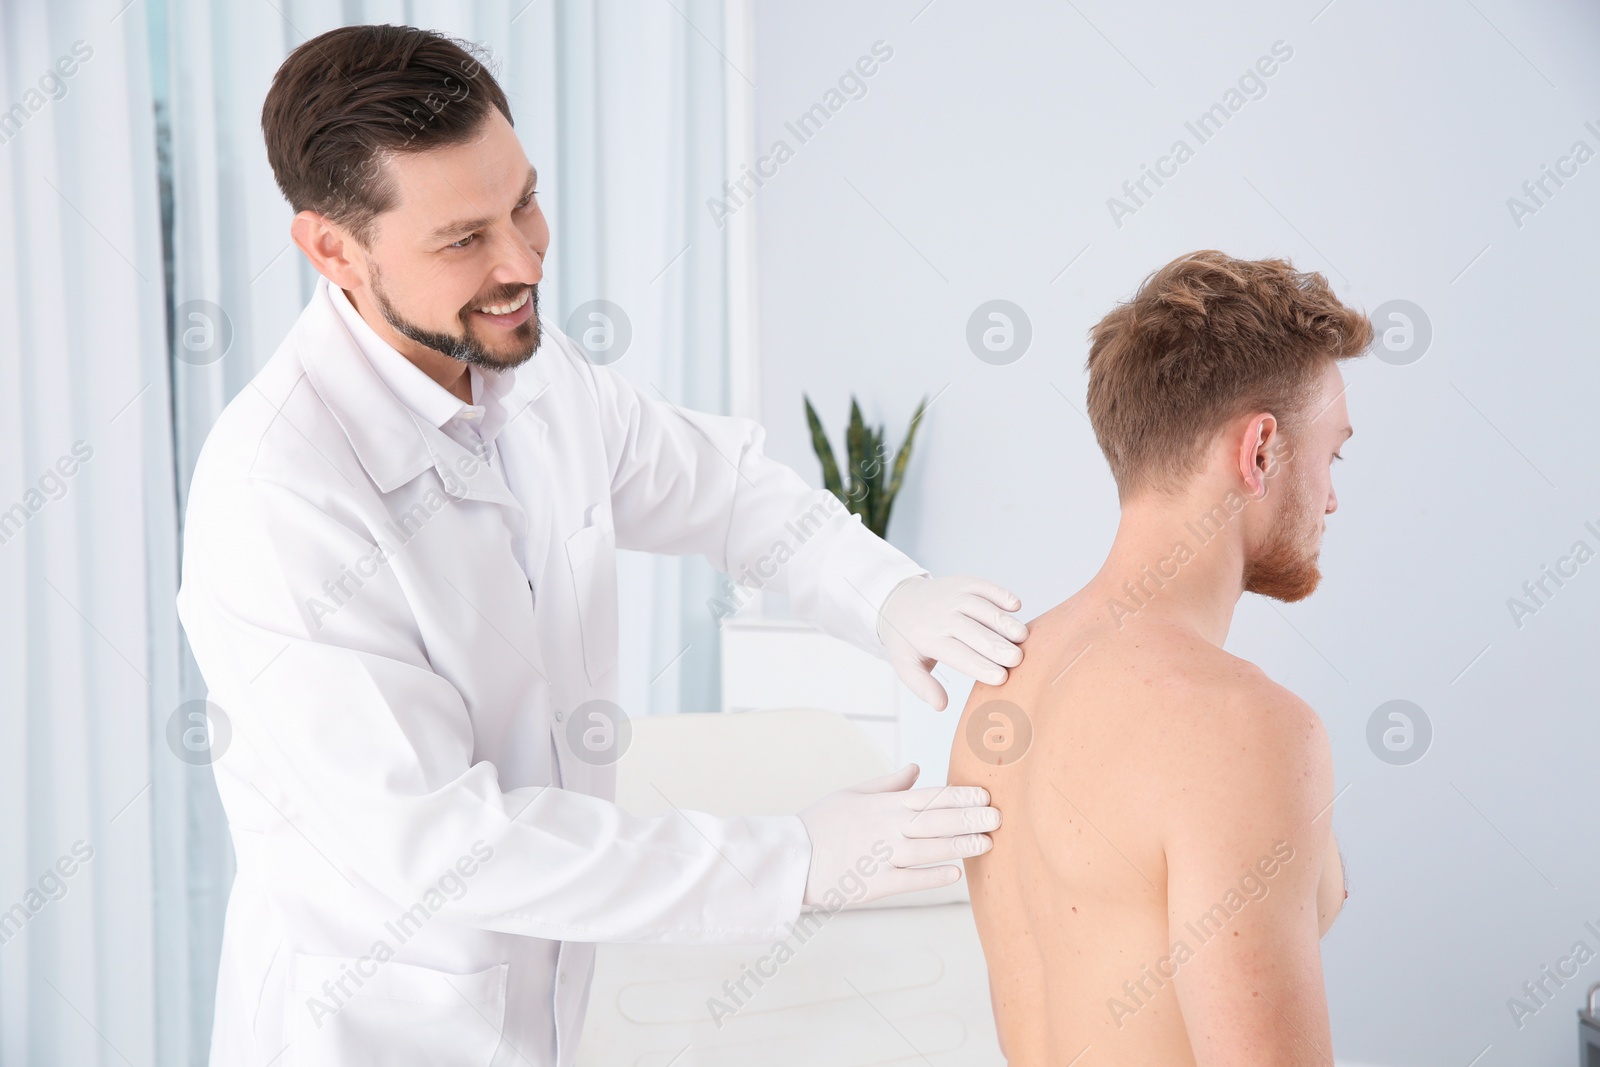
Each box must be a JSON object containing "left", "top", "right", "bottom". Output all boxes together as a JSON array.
[{"left": 563, "top": 338, "right": 928, "bottom": 659}]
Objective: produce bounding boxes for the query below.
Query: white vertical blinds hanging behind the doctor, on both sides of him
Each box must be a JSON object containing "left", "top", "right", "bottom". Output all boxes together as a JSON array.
[{"left": 0, "top": 0, "right": 742, "bottom": 1067}]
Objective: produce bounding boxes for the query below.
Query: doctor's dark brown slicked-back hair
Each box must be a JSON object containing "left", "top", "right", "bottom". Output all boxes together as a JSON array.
[{"left": 261, "top": 26, "right": 515, "bottom": 246}]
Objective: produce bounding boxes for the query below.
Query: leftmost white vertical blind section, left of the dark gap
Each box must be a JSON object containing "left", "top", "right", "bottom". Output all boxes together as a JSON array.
[{"left": 0, "top": 2, "right": 178, "bottom": 1067}]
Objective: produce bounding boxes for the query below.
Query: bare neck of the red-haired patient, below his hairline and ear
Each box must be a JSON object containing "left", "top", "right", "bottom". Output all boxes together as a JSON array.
[{"left": 1080, "top": 490, "right": 1250, "bottom": 648}]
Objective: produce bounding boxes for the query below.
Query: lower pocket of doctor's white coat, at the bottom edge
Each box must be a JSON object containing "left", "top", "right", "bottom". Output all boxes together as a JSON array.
[{"left": 282, "top": 953, "right": 507, "bottom": 1067}]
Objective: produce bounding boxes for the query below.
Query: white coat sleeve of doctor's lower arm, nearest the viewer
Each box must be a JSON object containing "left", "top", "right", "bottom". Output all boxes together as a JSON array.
[{"left": 178, "top": 474, "right": 810, "bottom": 942}]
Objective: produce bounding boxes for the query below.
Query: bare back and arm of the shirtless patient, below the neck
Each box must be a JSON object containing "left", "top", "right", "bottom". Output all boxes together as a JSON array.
[{"left": 950, "top": 598, "right": 1344, "bottom": 1067}]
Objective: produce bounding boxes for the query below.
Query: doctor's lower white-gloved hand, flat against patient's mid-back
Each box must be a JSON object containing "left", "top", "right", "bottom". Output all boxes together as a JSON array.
[{"left": 800, "top": 763, "right": 1000, "bottom": 907}]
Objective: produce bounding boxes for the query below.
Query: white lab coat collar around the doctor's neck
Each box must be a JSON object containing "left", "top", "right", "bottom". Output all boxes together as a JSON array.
[{"left": 294, "top": 278, "right": 549, "bottom": 514}]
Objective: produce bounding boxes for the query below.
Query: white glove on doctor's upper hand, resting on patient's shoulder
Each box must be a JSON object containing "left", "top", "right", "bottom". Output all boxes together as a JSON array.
[{"left": 878, "top": 574, "right": 1027, "bottom": 712}]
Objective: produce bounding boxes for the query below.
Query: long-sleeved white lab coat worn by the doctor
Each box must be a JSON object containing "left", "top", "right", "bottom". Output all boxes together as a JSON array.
[{"left": 178, "top": 280, "right": 926, "bottom": 1067}]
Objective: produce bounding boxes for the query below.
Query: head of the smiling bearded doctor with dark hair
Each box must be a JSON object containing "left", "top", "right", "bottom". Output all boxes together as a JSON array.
[{"left": 261, "top": 26, "right": 550, "bottom": 400}]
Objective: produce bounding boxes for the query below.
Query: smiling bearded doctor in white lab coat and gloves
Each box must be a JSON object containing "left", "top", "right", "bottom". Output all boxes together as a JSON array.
[{"left": 178, "top": 26, "right": 1026, "bottom": 1067}]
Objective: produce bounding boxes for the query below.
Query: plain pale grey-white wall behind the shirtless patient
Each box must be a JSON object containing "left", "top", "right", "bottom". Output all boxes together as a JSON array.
[{"left": 744, "top": 0, "right": 1600, "bottom": 1067}]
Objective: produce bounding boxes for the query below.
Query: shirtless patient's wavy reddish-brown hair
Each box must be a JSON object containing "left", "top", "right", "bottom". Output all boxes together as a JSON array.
[{"left": 1086, "top": 250, "right": 1373, "bottom": 501}]
